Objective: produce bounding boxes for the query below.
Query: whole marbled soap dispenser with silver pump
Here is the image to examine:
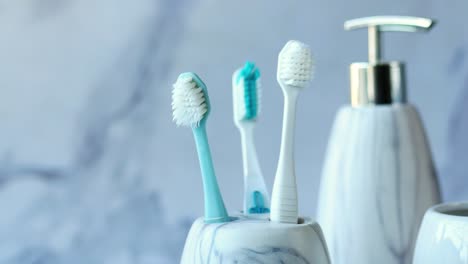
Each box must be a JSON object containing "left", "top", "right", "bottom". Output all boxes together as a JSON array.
[{"left": 317, "top": 16, "right": 440, "bottom": 264}]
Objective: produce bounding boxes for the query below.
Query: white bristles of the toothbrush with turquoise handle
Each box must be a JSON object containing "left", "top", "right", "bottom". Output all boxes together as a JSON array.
[{"left": 172, "top": 77, "right": 208, "bottom": 126}]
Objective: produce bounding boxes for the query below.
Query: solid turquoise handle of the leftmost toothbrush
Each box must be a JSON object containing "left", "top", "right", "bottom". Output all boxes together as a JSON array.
[{"left": 193, "top": 123, "right": 229, "bottom": 223}]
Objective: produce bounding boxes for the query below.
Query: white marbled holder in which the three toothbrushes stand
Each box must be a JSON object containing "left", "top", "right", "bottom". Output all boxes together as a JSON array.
[{"left": 181, "top": 216, "right": 330, "bottom": 264}]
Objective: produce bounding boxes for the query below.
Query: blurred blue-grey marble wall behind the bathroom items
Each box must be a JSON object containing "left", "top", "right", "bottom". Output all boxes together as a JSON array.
[{"left": 0, "top": 0, "right": 468, "bottom": 264}]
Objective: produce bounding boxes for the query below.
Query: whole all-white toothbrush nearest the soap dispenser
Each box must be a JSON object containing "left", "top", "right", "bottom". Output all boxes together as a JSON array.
[{"left": 270, "top": 40, "right": 313, "bottom": 224}]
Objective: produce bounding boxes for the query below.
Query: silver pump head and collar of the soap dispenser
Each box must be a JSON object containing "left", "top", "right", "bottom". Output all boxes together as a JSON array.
[{"left": 344, "top": 16, "right": 434, "bottom": 106}]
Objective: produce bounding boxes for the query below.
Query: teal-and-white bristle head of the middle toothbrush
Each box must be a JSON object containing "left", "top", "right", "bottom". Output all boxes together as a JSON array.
[{"left": 236, "top": 62, "right": 261, "bottom": 120}]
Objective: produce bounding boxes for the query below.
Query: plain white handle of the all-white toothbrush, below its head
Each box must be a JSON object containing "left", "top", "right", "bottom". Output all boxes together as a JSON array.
[{"left": 270, "top": 90, "right": 298, "bottom": 224}]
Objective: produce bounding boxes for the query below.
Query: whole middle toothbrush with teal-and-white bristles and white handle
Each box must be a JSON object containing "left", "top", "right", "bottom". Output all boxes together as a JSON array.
[{"left": 232, "top": 62, "right": 270, "bottom": 218}]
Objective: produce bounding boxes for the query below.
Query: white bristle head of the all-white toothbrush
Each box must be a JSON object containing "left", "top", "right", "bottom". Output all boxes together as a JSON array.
[{"left": 277, "top": 40, "right": 314, "bottom": 88}]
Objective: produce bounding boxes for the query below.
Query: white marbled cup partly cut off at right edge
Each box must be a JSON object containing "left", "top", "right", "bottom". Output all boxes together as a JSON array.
[{"left": 413, "top": 202, "right": 468, "bottom": 264}]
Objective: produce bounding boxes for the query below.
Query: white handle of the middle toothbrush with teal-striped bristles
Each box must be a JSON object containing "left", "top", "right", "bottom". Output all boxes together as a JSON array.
[{"left": 239, "top": 122, "right": 270, "bottom": 214}]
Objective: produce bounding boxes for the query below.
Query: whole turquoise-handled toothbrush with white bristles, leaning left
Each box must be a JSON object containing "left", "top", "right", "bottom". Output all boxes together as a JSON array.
[{"left": 172, "top": 72, "right": 230, "bottom": 223}]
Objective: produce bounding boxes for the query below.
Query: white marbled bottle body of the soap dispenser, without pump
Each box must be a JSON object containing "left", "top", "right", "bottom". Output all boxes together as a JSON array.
[{"left": 317, "top": 104, "right": 440, "bottom": 264}]
